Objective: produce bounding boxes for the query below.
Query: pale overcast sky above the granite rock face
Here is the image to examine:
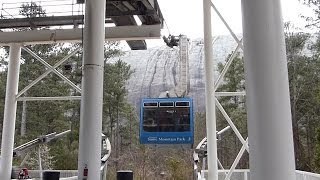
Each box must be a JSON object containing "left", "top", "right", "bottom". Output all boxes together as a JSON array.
[{"left": 148, "top": 0, "right": 313, "bottom": 47}]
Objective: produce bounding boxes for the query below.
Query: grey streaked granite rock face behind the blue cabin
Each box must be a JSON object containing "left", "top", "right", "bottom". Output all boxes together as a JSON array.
[{"left": 111, "top": 36, "right": 237, "bottom": 111}]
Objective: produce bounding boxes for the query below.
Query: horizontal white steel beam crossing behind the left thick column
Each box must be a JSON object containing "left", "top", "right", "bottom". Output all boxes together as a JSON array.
[{"left": 0, "top": 24, "right": 161, "bottom": 46}]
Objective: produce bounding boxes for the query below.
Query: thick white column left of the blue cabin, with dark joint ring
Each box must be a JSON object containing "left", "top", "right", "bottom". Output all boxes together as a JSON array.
[{"left": 78, "top": 0, "right": 106, "bottom": 180}]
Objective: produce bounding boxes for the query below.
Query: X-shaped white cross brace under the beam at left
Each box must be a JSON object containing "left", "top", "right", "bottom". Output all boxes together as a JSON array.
[{"left": 21, "top": 47, "right": 81, "bottom": 94}]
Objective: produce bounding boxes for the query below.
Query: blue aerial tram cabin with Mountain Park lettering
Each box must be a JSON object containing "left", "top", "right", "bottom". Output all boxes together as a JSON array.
[{"left": 140, "top": 98, "right": 194, "bottom": 147}]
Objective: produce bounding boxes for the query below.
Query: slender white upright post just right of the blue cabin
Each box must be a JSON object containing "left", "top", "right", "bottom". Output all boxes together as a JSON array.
[{"left": 203, "top": 0, "right": 218, "bottom": 180}]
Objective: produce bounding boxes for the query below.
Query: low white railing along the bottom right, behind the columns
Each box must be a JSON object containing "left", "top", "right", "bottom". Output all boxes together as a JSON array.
[{"left": 197, "top": 169, "right": 320, "bottom": 180}]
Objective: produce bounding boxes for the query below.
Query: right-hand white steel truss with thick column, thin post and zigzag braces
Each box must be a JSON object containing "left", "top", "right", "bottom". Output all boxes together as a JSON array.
[{"left": 198, "top": 0, "right": 295, "bottom": 180}]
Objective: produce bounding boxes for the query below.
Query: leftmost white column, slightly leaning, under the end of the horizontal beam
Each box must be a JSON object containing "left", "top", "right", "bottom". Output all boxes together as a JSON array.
[{"left": 0, "top": 44, "right": 21, "bottom": 180}]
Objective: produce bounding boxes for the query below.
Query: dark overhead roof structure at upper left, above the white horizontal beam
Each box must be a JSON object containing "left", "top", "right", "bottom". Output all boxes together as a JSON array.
[{"left": 0, "top": 0, "right": 163, "bottom": 50}]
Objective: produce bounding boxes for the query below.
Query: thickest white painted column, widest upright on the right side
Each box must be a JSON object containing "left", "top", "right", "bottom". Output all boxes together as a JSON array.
[{"left": 242, "top": 0, "right": 295, "bottom": 180}]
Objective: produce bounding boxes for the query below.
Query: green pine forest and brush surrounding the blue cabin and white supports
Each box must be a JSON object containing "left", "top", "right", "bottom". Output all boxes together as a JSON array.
[{"left": 0, "top": 0, "right": 320, "bottom": 180}]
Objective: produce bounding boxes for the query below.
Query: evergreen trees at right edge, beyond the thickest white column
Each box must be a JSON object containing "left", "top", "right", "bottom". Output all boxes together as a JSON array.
[{"left": 286, "top": 24, "right": 320, "bottom": 171}]
